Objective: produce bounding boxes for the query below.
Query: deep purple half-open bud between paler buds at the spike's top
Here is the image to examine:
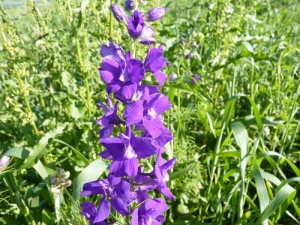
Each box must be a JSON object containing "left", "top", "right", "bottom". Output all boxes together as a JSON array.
[{"left": 127, "top": 10, "right": 144, "bottom": 39}]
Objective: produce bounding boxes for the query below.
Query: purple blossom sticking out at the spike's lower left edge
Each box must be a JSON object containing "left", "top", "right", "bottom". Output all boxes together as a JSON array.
[{"left": 80, "top": 174, "right": 134, "bottom": 223}]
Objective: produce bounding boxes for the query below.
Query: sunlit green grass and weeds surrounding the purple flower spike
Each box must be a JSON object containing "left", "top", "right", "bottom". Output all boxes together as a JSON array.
[{"left": 0, "top": 0, "right": 300, "bottom": 225}]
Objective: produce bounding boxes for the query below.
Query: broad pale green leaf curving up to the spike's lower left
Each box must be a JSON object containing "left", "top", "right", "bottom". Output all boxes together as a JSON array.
[{"left": 72, "top": 159, "right": 109, "bottom": 201}]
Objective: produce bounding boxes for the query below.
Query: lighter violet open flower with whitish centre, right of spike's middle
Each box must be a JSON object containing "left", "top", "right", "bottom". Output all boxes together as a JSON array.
[{"left": 124, "top": 93, "right": 171, "bottom": 138}]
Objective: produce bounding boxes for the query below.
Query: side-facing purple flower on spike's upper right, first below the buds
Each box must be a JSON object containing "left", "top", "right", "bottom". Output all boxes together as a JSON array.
[{"left": 144, "top": 47, "right": 167, "bottom": 86}]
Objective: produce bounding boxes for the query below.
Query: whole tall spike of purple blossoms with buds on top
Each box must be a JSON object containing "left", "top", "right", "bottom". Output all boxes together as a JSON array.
[{"left": 81, "top": 0, "right": 176, "bottom": 225}]
